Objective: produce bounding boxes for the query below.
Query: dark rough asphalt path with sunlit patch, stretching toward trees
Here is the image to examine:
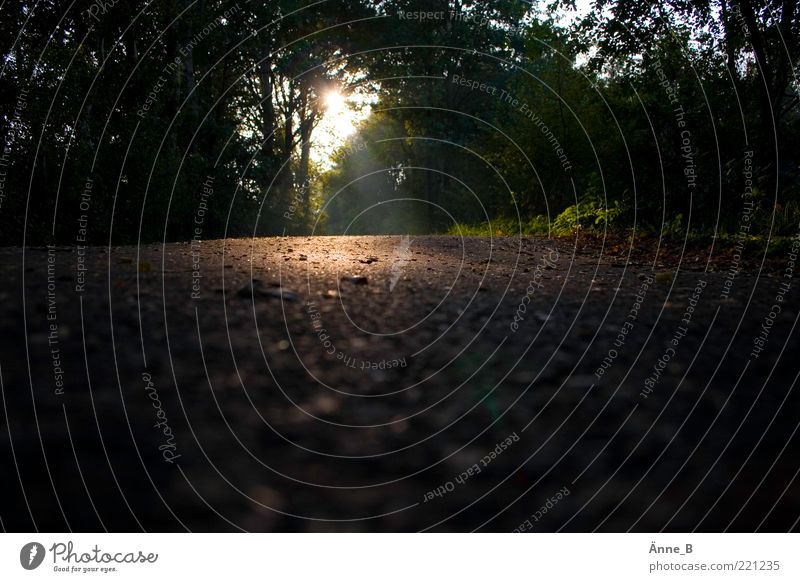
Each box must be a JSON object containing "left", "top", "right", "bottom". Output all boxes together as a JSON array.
[{"left": 0, "top": 236, "right": 800, "bottom": 531}]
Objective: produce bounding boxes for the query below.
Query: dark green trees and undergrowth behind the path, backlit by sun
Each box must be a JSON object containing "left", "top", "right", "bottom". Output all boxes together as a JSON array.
[{"left": 0, "top": 0, "right": 800, "bottom": 245}]
